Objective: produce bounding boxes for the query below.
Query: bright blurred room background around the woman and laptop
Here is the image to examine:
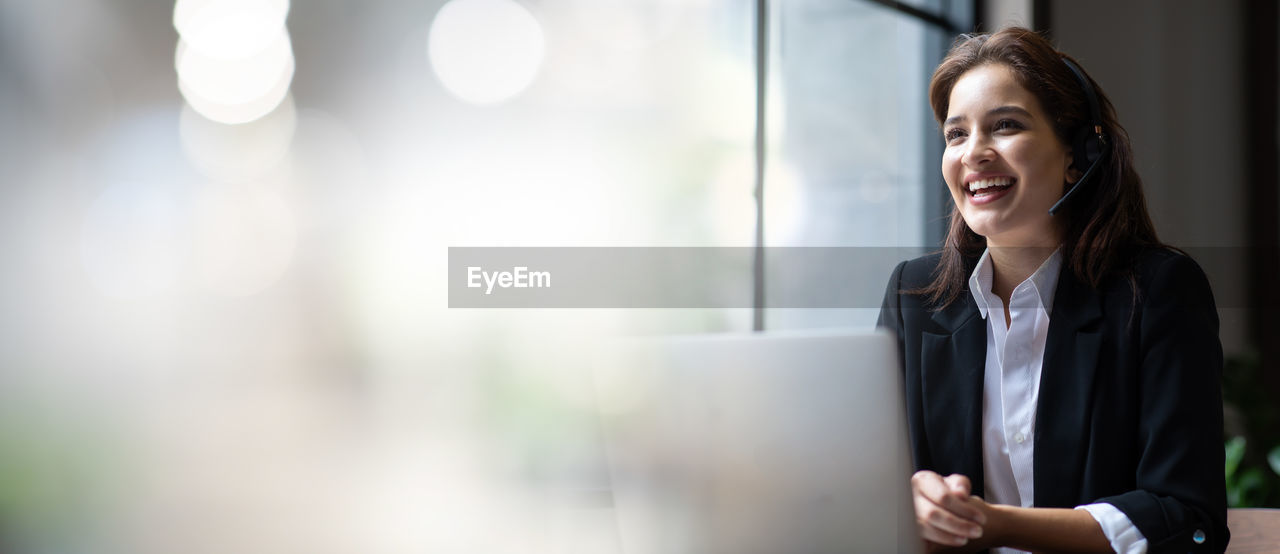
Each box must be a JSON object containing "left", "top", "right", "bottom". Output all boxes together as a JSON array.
[{"left": 0, "top": 0, "right": 1280, "bottom": 553}]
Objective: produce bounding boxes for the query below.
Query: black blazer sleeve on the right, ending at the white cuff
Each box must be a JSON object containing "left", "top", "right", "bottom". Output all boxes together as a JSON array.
[{"left": 1100, "top": 255, "right": 1230, "bottom": 553}]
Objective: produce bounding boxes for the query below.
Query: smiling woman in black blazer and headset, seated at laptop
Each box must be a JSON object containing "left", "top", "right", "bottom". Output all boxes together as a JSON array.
[{"left": 879, "top": 28, "right": 1229, "bottom": 551}]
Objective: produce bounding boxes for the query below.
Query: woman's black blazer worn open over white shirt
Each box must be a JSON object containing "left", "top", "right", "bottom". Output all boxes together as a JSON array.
[{"left": 879, "top": 248, "right": 1230, "bottom": 551}]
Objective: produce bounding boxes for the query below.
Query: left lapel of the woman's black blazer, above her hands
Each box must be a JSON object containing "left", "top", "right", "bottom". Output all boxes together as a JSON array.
[{"left": 920, "top": 294, "right": 987, "bottom": 495}]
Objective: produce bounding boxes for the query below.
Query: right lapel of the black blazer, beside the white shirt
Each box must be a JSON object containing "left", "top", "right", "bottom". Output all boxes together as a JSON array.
[{"left": 1032, "top": 267, "right": 1102, "bottom": 507}]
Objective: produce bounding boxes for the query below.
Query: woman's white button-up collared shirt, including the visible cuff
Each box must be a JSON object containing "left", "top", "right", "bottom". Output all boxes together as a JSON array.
[{"left": 969, "top": 249, "right": 1147, "bottom": 554}]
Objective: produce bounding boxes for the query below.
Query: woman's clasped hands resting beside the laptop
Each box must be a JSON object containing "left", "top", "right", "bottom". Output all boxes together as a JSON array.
[{"left": 911, "top": 471, "right": 987, "bottom": 550}]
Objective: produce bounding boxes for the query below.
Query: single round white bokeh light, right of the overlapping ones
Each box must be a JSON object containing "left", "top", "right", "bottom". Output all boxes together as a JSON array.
[{"left": 428, "top": 0, "right": 545, "bottom": 105}]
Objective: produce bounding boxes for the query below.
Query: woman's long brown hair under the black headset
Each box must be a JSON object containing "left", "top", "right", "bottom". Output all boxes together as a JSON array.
[{"left": 909, "top": 27, "right": 1164, "bottom": 310}]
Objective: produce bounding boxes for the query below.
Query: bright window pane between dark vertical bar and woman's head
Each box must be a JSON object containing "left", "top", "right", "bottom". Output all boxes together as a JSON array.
[{"left": 764, "top": 0, "right": 972, "bottom": 329}]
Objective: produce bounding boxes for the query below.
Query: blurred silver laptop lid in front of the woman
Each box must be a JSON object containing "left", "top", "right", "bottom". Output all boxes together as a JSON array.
[{"left": 594, "top": 333, "right": 922, "bottom": 554}]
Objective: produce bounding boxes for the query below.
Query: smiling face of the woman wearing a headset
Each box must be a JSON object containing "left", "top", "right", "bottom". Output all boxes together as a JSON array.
[{"left": 942, "top": 64, "right": 1078, "bottom": 246}]
